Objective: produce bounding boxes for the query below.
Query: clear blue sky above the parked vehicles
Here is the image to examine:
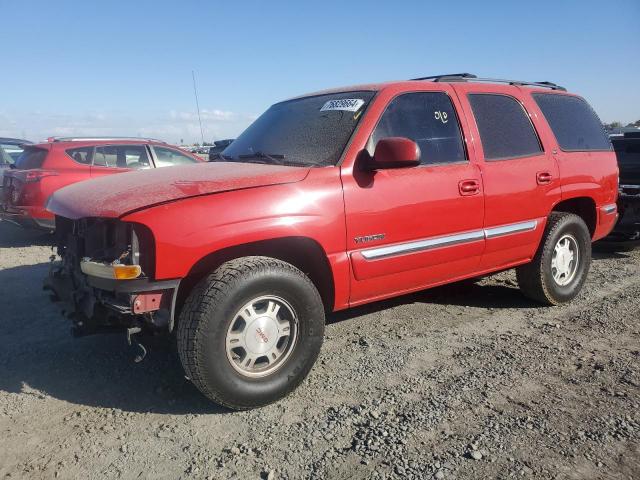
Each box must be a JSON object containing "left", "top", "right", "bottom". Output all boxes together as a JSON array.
[{"left": 0, "top": 0, "right": 640, "bottom": 143}]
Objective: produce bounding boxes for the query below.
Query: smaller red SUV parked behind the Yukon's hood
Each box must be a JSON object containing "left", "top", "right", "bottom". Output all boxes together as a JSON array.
[{"left": 0, "top": 138, "right": 203, "bottom": 230}]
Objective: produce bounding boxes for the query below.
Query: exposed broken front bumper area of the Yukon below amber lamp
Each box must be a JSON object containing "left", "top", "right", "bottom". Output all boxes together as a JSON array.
[{"left": 44, "top": 262, "right": 180, "bottom": 336}]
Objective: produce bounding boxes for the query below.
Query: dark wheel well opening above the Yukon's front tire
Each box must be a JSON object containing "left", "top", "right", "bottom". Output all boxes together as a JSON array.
[{"left": 176, "top": 236, "right": 335, "bottom": 314}]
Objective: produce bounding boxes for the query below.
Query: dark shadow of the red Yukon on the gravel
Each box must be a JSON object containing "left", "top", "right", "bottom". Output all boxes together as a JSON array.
[{"left": 0, "top": 256, "right": 535, "bottom": 415}]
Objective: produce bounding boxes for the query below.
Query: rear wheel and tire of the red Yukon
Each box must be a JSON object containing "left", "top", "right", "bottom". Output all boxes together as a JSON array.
[{"left": 516, "top": 212, "right": 591, "bottom": 305}]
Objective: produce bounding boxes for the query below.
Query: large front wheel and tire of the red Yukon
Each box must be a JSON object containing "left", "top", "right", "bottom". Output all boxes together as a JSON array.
[{"left": 177, "top": 257, "right": 325, "bottom": 410}]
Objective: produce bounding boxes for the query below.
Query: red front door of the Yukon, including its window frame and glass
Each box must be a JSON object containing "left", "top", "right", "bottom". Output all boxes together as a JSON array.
[{"left": 342, "top": 84, "right": 485, "bottom": 305}]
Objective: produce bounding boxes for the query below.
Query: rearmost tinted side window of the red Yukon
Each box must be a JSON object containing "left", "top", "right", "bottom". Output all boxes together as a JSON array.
[{"left": 533, "top": 93, "right": 611, "bottom": 152}]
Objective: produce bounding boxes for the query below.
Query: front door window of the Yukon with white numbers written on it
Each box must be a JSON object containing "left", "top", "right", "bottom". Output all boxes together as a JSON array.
[{"left": 367, "top": 92, "right": 466, "bottom": 165}]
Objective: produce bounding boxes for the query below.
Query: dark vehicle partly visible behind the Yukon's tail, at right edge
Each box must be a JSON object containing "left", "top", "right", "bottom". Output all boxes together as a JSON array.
[{"left": 602, "top": 130, "right": 640, "bottom": 249}]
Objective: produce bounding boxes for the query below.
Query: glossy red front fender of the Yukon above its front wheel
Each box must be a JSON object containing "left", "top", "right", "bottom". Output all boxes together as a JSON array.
[{"left": 122, "top": 167, "right": 348, "bottom": 304}]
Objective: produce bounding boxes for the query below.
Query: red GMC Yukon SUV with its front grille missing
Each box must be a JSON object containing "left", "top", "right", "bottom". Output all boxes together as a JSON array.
[{"left": 47, "top": 74, "right": 618, "bottom": 409}]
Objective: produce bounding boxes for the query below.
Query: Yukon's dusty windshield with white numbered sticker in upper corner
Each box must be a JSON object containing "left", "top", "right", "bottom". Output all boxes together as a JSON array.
[{"left": 220, "top": 92, "right": 374, "bottom": 167}]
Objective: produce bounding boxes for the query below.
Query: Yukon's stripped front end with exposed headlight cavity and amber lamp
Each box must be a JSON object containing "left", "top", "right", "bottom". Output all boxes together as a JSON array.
[{"left": 44, "top": 216, "right": 180, "bottom": 336}]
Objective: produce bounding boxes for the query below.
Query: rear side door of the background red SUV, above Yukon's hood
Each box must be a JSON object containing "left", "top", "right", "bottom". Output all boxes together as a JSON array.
[{"left": 91, "top": 144, "right": 153, "bottom": 177}]
